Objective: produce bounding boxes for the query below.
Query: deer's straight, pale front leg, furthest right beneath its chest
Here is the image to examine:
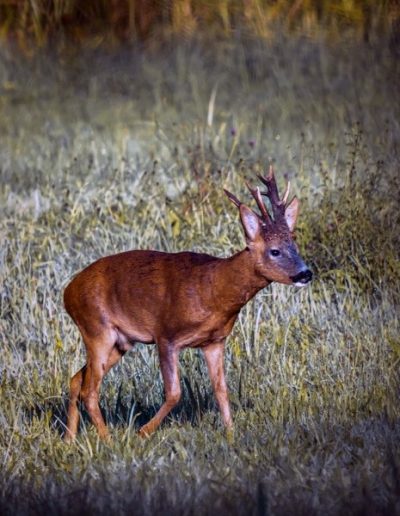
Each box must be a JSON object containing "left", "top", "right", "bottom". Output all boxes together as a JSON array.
[{"left": 203, "top": 341, "right": 233, "bottom": 430}]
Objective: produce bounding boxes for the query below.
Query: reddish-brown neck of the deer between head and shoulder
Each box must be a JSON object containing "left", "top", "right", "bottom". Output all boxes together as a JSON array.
[{"left": 215, "top": 249, "right": 270, "bottom": 313}]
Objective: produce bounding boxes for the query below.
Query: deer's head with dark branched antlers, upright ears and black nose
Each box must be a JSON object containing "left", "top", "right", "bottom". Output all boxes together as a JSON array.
[{"left": 225, "top": 166, "right": 312, "bottom": 286}]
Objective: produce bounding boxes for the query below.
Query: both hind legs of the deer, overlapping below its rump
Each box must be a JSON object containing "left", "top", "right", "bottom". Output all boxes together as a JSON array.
[{"left": 64, "top": 330, "right": 125, "bottom": 442}]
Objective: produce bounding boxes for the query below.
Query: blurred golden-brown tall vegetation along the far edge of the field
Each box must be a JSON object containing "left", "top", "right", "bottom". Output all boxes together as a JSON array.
[{"left": 0, "top": 0, "right": 400, "bottom": 54}]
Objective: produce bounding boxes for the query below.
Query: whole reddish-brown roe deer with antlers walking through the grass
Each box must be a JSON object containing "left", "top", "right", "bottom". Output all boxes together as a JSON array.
[{"left": 64, "top": 166, "right": 312, "bottom": 442}]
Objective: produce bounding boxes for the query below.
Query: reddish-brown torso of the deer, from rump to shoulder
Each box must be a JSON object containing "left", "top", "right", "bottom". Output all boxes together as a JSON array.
[{"left": 64, "top": 251, "right": 225, "bottom": 342}]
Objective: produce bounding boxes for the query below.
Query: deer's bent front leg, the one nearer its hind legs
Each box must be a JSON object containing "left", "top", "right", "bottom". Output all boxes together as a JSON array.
[{"left": 139, "top": 343, "right": 181, "bottom": 437}]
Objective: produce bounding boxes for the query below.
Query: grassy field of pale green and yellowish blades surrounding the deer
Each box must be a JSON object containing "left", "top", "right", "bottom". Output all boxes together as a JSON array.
[{"left": 0, "top": 26, "right": 400, "bottom": 516}]
